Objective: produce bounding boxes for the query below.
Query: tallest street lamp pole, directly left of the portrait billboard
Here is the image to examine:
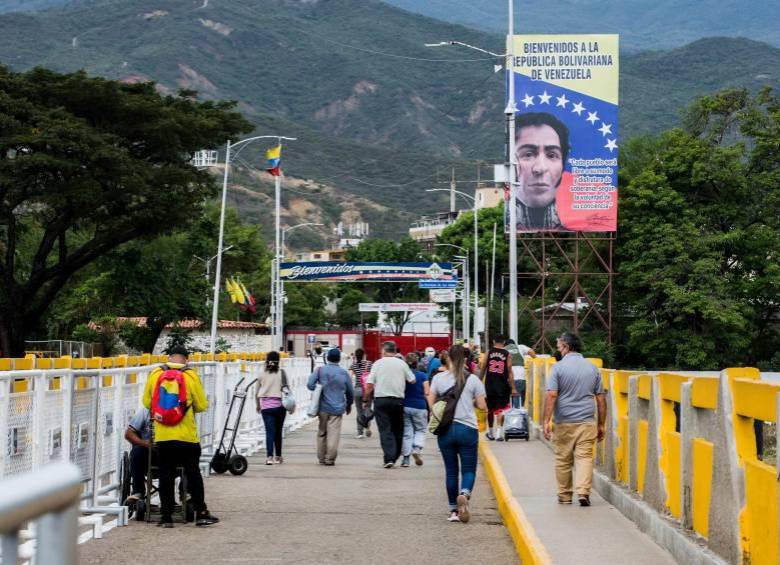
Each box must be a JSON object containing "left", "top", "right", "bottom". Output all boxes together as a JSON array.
[{"left": 425, "top": 0, "right": 517, "bottom": 342}]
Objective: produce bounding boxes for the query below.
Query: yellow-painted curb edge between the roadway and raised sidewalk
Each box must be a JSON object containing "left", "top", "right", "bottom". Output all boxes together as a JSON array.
[{"left": 479, "top": 441, "right": 552, "bottom": 565}]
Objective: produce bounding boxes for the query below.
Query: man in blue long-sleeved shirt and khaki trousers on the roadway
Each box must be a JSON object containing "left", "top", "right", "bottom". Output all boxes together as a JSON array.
[{"left": 307, "top": 347, "right": 355, "bottom": 466}]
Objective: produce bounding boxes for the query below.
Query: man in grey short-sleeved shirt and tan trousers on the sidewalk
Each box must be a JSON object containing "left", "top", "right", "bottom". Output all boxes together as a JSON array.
[{"left": 544, "top": 332, "right": 607, "bottom": 506}]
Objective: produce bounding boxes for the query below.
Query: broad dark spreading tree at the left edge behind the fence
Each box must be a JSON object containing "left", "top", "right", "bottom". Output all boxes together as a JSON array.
[{"left": 0, "top": 67, "right": 251, "bottom": 355}]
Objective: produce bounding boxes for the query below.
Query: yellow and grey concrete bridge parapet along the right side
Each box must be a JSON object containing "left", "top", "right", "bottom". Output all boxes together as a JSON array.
[{"left": 527, "top": 359, "right": 780, "bottom": 564}]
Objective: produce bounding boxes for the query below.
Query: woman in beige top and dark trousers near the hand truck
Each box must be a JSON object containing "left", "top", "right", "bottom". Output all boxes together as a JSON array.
[{"left": 256, "top": 351, "right": 287, "bottom": 465}]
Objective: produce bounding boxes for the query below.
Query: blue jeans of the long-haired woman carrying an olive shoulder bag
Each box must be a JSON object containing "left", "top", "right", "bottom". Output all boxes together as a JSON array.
[{"left": 439, "top": 422, "right": 479, "bottom": 510}]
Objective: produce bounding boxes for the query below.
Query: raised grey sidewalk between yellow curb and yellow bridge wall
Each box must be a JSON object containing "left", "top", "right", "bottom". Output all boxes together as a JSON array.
[{"left": 490, "top": 440, "right": 675, "bottom": 565}]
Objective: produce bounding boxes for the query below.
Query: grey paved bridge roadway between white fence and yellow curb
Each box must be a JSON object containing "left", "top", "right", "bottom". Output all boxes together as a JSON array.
[{"left": 80, "top": 418, "right": 518, "bottom": 565}]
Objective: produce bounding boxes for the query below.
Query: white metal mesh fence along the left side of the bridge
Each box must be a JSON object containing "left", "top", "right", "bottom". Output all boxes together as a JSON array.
[{"left": 0, "top": 358, "right": 311, "bottom": 560}]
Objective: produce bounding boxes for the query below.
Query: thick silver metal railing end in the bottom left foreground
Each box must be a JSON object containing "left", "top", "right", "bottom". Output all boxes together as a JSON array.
[{"left": 0, "top": 463, "right": 81, "bottom": 565}]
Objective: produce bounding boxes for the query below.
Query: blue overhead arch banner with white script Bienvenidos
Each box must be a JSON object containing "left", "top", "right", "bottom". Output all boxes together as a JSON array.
[{"left": 279, "top": 261, "right": 457, "bottom": 283}]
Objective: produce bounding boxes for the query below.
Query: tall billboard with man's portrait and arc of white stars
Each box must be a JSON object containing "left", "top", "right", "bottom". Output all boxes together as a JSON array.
[{"left": 504, "top": 35, "right": 619, "bottom": 233}]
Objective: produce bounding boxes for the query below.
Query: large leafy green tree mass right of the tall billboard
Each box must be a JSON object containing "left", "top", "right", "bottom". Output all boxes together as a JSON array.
[{"left": 616, "top": 90, "right": 780, "bottom": 369}]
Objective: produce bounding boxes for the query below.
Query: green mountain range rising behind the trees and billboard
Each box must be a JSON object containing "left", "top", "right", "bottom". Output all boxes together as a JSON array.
[{"left": 0, "top": 0, "right": 780, "bottom": 240}]
